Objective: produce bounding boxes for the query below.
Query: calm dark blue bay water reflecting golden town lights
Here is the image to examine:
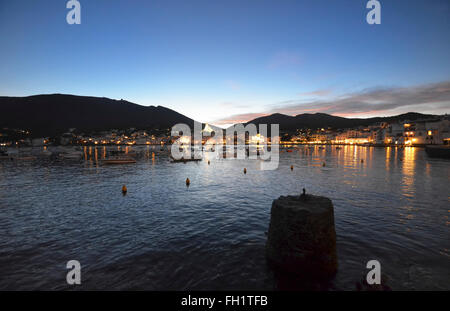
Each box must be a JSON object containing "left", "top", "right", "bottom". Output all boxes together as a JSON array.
[{"left": 0, "top": 146, "right": 450, "bottom": 290}]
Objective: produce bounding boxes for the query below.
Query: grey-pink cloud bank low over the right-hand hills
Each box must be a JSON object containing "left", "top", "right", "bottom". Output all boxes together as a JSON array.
[{"left": 217, "top": 81, "right": 450, "bottom": 124}]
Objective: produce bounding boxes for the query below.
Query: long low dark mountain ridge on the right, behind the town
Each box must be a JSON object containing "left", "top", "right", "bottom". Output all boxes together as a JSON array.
[{"left": 245, "top": 112, "right": 436, "bottom": 132}]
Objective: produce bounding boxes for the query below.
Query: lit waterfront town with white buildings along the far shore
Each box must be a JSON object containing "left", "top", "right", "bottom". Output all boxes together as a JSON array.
[{"left": 0, "top": 115, "right": 450, "bottom": 147}]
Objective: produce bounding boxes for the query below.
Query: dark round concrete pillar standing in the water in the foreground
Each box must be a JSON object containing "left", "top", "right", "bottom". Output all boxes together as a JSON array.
[{"left": 266, "top": 194, "right": 337, "bottom": 278}]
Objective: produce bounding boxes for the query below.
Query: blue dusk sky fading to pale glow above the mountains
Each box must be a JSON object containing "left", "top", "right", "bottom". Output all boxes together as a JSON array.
[{"left": 0, "top": 0, "right": 450, "bottom": 125}]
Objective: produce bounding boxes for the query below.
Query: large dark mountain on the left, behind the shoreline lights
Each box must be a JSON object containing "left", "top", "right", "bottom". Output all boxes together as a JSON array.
[{"left": 0, "top": 94, "right": 194, "bottom": 136}]
